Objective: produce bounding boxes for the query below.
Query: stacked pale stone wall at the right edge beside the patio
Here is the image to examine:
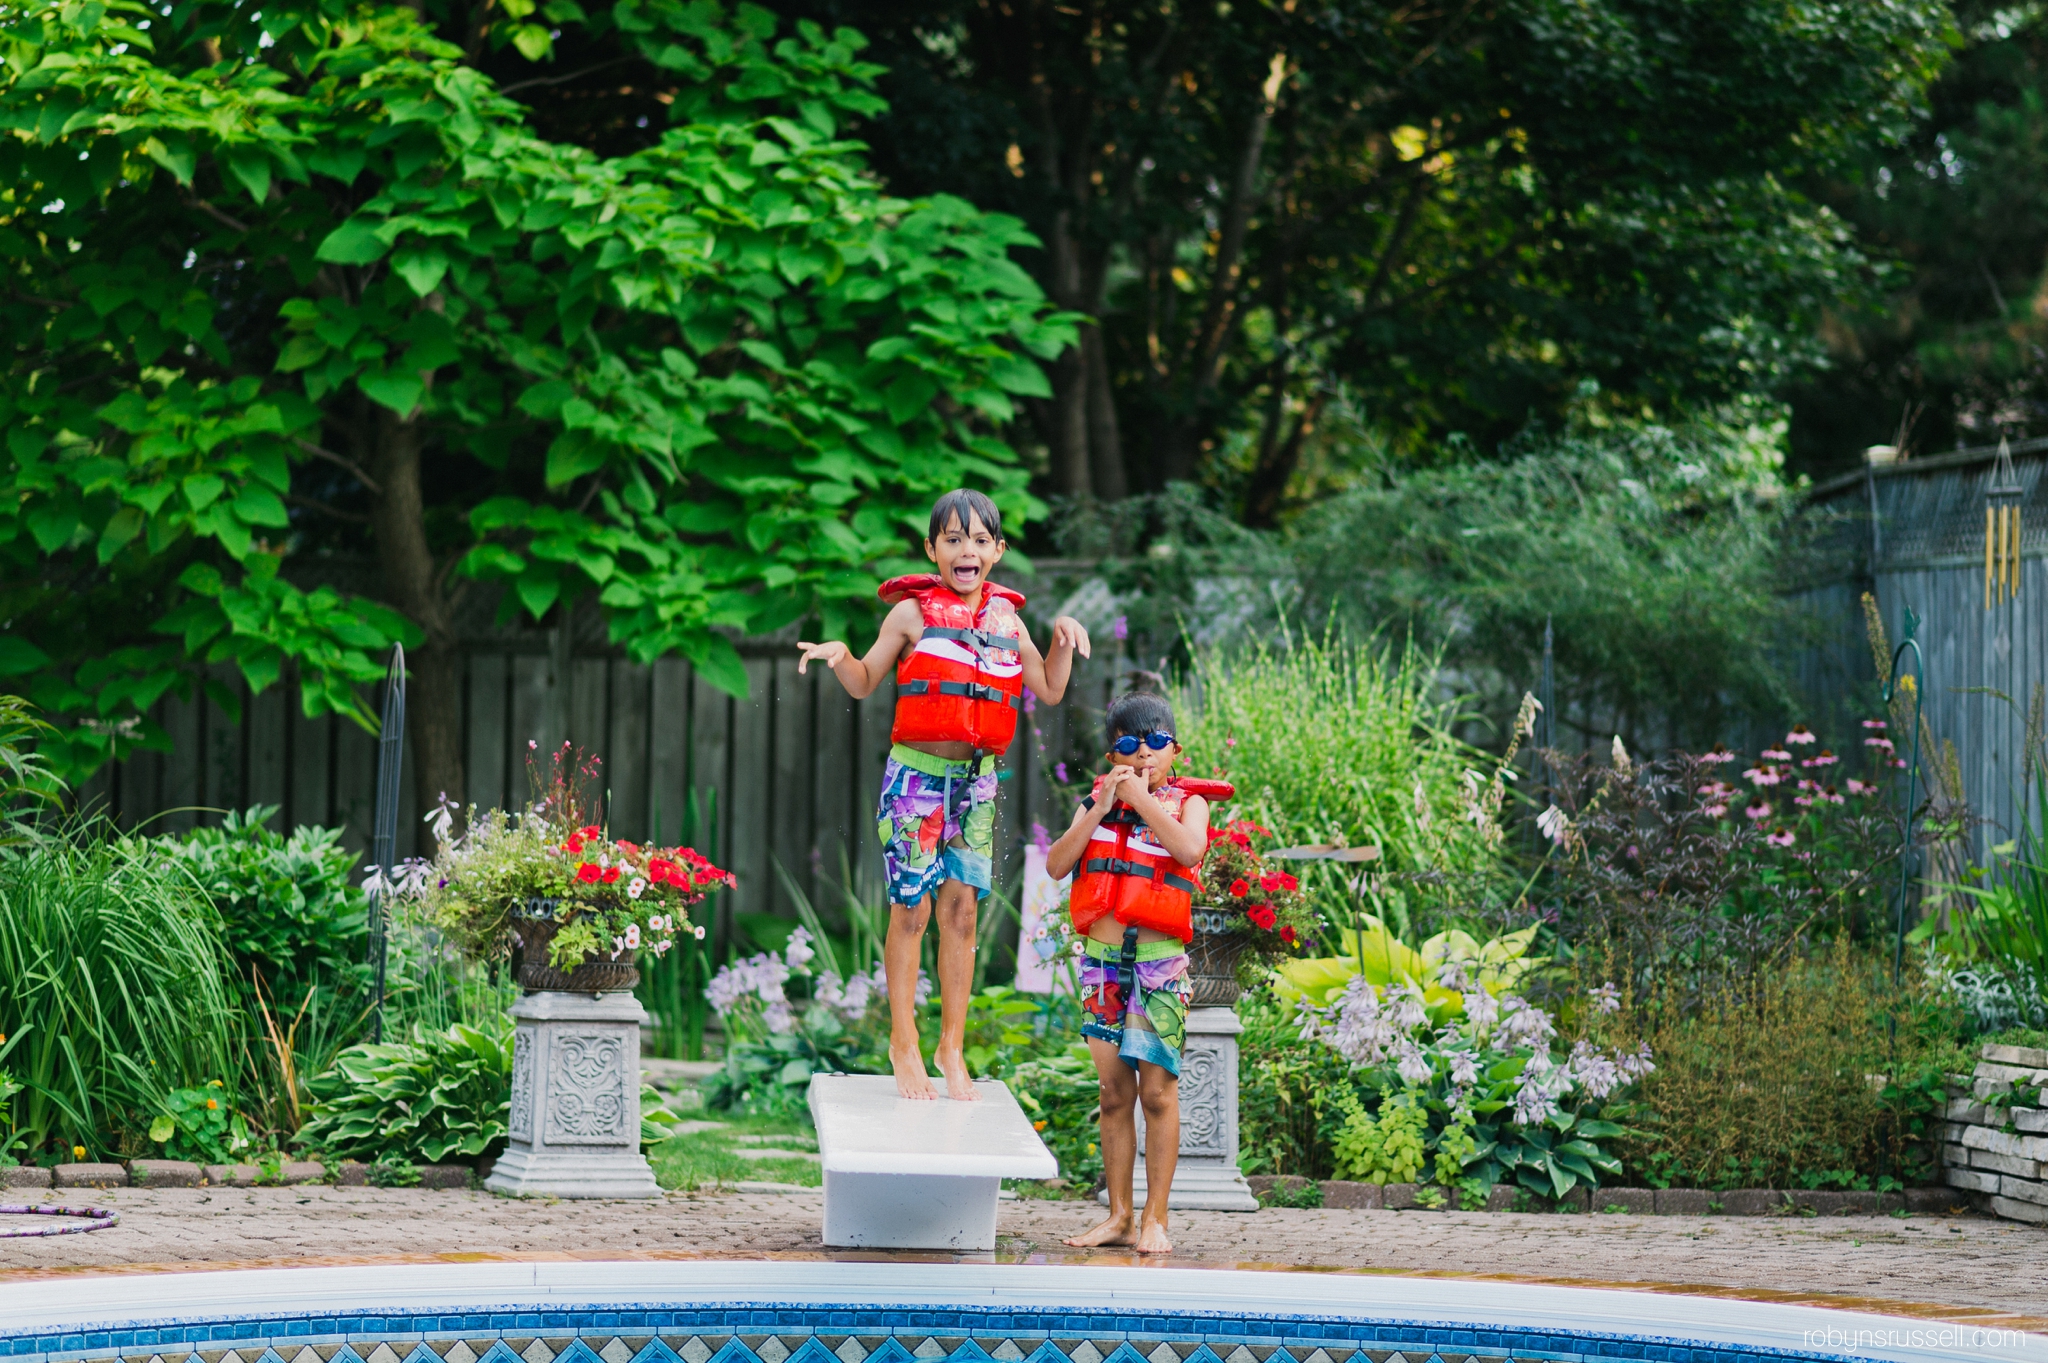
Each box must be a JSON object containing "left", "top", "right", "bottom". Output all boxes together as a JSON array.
[{"left": 1942, "top": 1046, "right": 2048, "bottom": 1226}]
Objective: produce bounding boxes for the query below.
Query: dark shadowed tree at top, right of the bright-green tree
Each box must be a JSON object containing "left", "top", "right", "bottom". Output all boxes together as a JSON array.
[{"left": 776, "top": 0, "right": 1948, "bottom": 522}]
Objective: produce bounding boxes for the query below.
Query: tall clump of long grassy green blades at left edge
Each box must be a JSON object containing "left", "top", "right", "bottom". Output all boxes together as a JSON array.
[{"left": 0, "top": 829, "right": 248, "bottom": 1156}]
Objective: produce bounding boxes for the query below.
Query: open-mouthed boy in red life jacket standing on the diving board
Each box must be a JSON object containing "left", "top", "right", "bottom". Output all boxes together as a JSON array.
[{"left": 797, "top": 487, "right": 1090, "bottom": 1099}]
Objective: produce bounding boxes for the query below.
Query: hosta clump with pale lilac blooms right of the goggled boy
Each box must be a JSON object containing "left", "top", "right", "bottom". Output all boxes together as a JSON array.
[{"left": 1296, "top": 964, "right": 1655, "bottom": 1205}]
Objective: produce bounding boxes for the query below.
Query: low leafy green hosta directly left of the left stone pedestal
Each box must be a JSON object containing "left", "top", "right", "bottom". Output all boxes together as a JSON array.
[{"left": 295, "top": 1023, "right": 512, "bottom": 1164}]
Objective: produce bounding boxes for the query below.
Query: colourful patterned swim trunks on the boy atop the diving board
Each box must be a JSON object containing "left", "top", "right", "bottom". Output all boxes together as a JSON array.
[{"left": 874, "top": 743, "right": 995, "bottom": 905}]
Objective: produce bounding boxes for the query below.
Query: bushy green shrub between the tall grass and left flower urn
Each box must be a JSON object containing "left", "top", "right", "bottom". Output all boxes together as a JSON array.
[{"left": 131, "top": 804, "right": 367, "bottom": 1009}]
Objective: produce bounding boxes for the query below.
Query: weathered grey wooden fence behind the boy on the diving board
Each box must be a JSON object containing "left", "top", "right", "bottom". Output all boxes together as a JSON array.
[{"left": 80, "top": 560, "right": 1118, "bottom": 933}]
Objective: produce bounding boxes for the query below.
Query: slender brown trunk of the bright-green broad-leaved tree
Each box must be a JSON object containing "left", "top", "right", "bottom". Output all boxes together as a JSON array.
[{"left": 371, "top": 407, "right": 465, "bottom": 834}]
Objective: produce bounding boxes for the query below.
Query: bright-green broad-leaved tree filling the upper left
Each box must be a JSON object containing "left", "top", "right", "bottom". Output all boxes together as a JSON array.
[{"left": 0, "top": 0, "right": 1073, "bottom": 800}]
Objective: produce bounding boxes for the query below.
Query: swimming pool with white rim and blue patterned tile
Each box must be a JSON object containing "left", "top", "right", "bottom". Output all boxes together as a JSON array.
[{"left": 0, "top": 1261, "right": 2023, "bottom": 1363}]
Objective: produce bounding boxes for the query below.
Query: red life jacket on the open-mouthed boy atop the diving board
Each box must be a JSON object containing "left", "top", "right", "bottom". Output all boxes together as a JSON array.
[{"left": 879, "top": 573, "right": 1024, "bottom": 753}]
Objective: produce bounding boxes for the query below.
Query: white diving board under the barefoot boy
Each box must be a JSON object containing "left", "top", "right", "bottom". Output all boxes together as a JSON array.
[{"left": 811, "top": 1074, "right": 1059, "bottom": 1250}]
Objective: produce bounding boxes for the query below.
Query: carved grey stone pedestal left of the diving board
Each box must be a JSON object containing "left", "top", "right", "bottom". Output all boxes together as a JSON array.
[{"left": 483, "top": 993, "right": 662, "bottom": 1197}]
